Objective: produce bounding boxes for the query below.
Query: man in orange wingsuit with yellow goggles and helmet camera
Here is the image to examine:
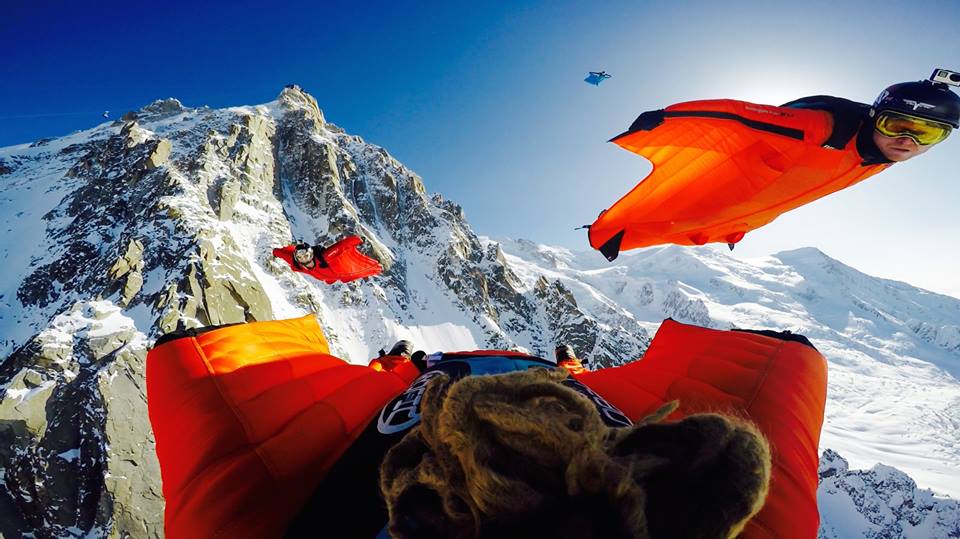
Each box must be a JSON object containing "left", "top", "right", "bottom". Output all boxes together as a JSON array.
[{"left": 588, "top": 69, "right": 960, "bottom": 260}]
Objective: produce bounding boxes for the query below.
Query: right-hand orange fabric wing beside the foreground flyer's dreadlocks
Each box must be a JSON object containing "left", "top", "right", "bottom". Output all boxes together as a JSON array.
[{"left": 575, "top": 320, "right": 827, "bottom": 538}]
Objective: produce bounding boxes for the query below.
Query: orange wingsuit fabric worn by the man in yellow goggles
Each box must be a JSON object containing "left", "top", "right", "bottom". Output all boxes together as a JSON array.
[{"left": 589, "top": 100, "right": 889, "bottom": 260}]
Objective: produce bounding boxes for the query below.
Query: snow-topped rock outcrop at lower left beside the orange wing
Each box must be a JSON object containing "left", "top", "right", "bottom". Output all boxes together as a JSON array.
[{"left": 0, "top": 302, "right": 163, "bottom": 537}]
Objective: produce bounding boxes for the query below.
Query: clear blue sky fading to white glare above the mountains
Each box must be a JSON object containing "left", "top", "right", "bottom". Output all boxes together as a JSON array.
[{"left": 0, "top": 0, "right": 960, "bottom": 297}]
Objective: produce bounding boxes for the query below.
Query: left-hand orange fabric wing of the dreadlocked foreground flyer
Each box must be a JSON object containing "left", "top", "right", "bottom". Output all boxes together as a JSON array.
[{"left": 147, "top": 315, "right": 416, "bottom": 538}]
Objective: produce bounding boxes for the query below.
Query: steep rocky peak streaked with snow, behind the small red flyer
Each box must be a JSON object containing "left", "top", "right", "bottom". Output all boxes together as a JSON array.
[{"left": 0, "top": 87, "right": 649, "bottom": 537}]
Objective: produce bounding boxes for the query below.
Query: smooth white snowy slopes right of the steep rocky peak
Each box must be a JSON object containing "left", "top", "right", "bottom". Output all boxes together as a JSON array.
[{"left": 499, "top": 240, "right": 960, "bottom": 539}]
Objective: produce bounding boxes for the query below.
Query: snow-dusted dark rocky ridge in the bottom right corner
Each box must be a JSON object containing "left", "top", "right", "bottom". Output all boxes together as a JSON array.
[{"left": 817, "top": 449, "right": 960, "bottom": 539}]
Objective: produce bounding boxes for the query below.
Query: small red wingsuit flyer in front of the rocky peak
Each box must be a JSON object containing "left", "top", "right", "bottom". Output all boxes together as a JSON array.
[{"left": 273, "top": 236, "right": 383, "bottom": 284}]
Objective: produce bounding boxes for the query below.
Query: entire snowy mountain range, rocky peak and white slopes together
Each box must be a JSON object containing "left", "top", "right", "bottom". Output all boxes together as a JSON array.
[{"left": 0, "top": 87, "right": 960, "bottom": 537}]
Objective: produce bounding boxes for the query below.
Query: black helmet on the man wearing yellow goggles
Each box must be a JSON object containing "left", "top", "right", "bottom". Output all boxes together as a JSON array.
[{"left": 873, "top": 80, "right": 960, "bottom": 129}]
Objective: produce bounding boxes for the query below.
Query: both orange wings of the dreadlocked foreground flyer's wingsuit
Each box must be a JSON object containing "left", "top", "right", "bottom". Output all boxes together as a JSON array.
[{"left": 147, "top": 315, "right": 826, "bottom": 539}]
